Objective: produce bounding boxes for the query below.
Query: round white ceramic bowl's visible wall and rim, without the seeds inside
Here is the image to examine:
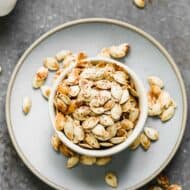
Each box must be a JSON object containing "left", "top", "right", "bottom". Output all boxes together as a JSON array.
[{"left": 49, "top": 57, "right": 148, "bottom": 157}]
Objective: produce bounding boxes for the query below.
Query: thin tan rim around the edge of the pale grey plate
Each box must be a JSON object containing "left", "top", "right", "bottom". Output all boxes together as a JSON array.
[{"left": 6, "top": 18, "right": 187, "bottom": 190}]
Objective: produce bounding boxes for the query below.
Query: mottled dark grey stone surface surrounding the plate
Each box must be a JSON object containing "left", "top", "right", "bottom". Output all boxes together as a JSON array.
[{"left": 0, "top": 0, "right": 190, "bottom": 190}]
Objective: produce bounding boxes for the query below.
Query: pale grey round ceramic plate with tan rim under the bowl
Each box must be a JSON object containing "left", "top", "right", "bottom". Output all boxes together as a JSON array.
[{"left": 6, "top": 19, "right": 187, "bottom": 190}]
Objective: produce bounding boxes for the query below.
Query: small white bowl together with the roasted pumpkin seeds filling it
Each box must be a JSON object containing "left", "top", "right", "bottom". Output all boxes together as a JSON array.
[{"left": 49, "top": 57, "right": 148, "bottom": 157}]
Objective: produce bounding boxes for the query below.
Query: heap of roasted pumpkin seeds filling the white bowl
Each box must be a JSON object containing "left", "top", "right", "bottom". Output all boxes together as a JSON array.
[{"left": 54, "top": 61, "right": 140, "bottom": 149}]
